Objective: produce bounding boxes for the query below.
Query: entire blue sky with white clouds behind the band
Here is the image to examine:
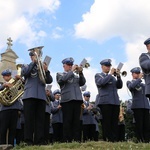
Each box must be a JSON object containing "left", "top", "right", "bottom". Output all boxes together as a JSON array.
[{"left": 0, "top": 0, "right": 150, "bottom": 100}]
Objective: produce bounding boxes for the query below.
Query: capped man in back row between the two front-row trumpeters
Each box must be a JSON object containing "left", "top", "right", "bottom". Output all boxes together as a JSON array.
[{"left": 82, "top": 91, "right": 96, "bottom": 142}]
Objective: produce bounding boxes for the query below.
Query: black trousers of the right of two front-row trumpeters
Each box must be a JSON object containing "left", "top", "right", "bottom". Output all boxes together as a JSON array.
[{"left": 100, "top": 104, "right": 120, "bottom": 142}]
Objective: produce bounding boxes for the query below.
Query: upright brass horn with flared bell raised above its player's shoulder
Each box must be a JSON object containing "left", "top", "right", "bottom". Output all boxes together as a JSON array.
[{"left": 28, "top": 46, "right": 46, "bottom": 84}]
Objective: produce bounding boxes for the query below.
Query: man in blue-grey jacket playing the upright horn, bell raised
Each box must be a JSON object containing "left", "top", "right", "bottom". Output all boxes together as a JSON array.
[{"left": 21, "top": 51, "right": 53, "bottom": 145}]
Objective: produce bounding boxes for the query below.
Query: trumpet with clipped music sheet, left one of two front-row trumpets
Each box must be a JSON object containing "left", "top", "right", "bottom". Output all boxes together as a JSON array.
[{"left": 74, "top": 58, "right": 90, "bottom": 74}]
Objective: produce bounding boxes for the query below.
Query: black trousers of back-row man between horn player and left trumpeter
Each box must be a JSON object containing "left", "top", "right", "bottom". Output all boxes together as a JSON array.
[{"left": 52, "top": 123, "right": 63, "bottom": 142}]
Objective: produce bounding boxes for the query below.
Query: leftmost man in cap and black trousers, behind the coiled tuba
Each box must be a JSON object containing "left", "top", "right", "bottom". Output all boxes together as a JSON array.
[{"left": 0, "top": 69, "right": 20, "bottom": 146}]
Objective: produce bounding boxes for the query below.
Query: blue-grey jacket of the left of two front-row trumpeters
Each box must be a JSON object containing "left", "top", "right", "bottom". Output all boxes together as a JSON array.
[{"left": 56, "top": 71, "right": 86, "bottom": 103}]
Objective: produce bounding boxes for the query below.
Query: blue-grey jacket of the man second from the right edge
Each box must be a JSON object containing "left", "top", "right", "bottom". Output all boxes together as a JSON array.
[{"left": 127, "top": 79, "right": 150, "bottom": 109}]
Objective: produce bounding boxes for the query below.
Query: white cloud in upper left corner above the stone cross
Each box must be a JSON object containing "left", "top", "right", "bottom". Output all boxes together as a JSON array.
[{"left": 0, "top": 0, "right": 60, "bottom": 48}]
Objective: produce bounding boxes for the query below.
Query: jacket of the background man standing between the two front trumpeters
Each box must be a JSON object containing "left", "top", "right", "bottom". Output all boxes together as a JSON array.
[{"left": 82, "top": 101, "right": 95, "bottom": 125}]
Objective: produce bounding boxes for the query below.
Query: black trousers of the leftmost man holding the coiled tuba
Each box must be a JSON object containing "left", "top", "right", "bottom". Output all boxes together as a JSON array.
[{"left": 0, "top": 109, "right": 18, "bottom": 146}]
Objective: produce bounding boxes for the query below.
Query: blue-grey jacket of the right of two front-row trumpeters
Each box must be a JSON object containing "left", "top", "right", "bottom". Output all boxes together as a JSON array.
[{"left": 95, "top": 73, "right": 123, "bottom": 105}]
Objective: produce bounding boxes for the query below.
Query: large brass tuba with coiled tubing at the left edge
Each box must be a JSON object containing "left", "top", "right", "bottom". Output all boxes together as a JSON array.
[{"left": 0, "top": 64, "right": 24, "bottom": 106}]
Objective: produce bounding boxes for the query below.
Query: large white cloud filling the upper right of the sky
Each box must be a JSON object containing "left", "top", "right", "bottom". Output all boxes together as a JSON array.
[{"left": 75, "top": 0, "right": 150, "bottom": 42}]
